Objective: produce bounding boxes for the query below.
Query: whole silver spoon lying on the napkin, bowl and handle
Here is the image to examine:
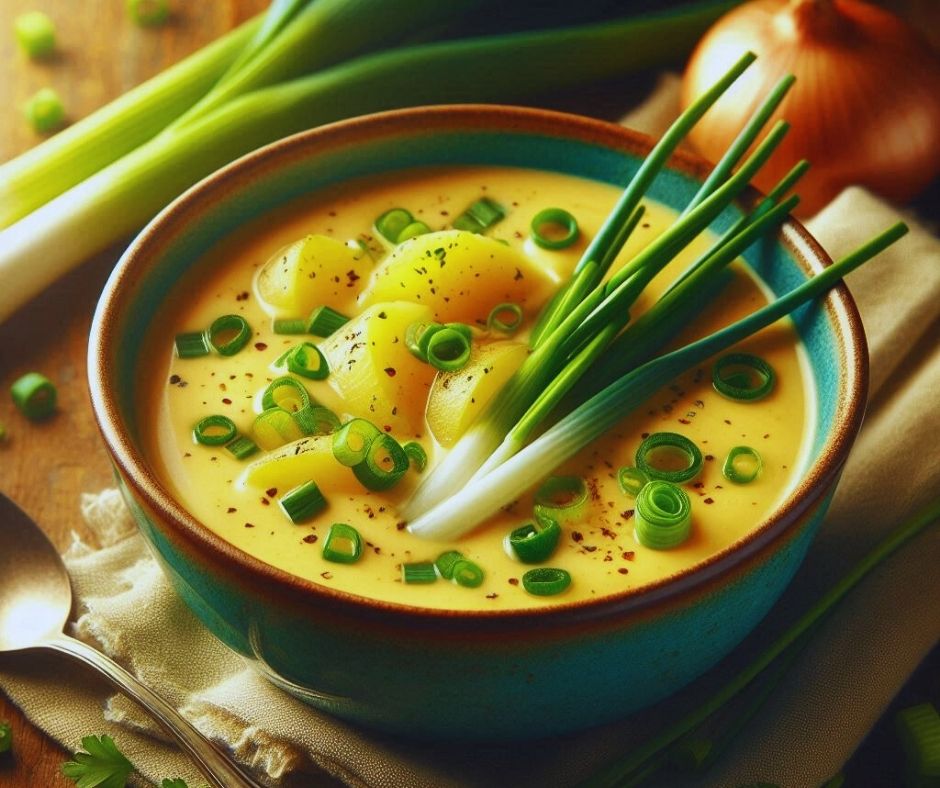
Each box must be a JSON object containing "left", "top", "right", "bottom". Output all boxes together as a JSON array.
[{"left": 0, "top": 493, "right": 261, "bottom": 788}]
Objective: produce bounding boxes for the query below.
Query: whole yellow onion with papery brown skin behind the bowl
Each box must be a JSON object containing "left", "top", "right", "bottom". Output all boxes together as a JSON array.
[{"left": 682, "top": 0, "right": 940, "bottom": 214}]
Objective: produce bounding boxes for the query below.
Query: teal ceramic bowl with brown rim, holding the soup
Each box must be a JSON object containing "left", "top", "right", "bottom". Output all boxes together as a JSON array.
[{"left": 89, "top": 106, "right": 867, "bottom": 739}]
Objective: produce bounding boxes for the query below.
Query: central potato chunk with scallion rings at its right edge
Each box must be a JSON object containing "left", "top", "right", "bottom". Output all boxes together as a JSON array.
[{"left": 320, "top": 301, "right": 435, "bottom": 435}]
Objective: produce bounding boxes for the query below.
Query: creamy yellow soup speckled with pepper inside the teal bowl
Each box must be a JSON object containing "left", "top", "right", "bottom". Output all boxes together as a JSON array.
[{"left": 140, "top": 168, "right": 812, "bottom": 610}]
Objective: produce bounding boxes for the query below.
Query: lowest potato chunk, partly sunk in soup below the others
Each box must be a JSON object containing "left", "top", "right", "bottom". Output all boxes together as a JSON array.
[{"left": 239, "top": 435, "right": 362, "bottom": 497}]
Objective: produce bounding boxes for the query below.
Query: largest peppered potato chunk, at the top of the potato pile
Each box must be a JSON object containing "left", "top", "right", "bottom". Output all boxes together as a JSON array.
[{"left": 362, "top": 230, "right": 552, "bottom": 326}]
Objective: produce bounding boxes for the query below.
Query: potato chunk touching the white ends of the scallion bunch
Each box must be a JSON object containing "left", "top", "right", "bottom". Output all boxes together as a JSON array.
[{"left": 427, "top": 342, "right": 529, "bottom": 446}]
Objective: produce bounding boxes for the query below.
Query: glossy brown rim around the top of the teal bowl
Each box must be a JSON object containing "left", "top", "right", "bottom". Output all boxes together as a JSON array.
[{"left": 88, "top": 104, "right": 868, "bottom": 626}]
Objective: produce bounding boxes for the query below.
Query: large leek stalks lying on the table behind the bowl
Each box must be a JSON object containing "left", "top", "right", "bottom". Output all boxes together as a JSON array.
[{"left": 0, "top": 0, "right": 733, "bottom": 320}]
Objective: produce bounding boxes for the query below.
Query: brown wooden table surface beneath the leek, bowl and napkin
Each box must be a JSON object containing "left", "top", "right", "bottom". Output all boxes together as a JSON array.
[{"left": 0, "top": 0, "right": 936, "bottom": 786}]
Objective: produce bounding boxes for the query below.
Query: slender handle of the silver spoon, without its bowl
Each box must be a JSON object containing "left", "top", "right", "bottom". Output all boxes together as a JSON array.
[{"left": 43, "top": 634, "right": 263, "bottom": 788}]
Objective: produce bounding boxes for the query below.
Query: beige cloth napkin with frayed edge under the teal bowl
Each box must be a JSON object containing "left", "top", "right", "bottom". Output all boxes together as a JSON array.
[{"left": 0, "top": 88, "right": 940, "bottom": 788}]
